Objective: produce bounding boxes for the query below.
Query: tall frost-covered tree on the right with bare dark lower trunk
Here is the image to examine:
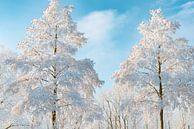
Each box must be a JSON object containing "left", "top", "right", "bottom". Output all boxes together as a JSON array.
[{"left": 114, "top": 9, "right": 194, "bottom": 129}]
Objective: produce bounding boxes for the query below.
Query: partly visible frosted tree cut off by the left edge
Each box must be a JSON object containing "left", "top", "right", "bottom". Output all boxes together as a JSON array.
[{"left": 0, "top": 46, "right": 27, "bottom": 129}]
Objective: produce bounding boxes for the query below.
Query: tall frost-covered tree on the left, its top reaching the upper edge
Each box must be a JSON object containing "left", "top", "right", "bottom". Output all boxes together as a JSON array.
[{"left": 10, "top": 0, "right": 103, "bottom": 129}]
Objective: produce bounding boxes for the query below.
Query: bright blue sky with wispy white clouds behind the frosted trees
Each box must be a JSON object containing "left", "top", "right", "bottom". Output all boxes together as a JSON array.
[{"left": 0, "top": 0, "right": 194, "bottom": 91}]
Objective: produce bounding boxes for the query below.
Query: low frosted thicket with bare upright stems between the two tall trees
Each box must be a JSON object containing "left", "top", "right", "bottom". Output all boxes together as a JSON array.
[{"left": 100, "top": 86, "right": 142, "bottom": 129}]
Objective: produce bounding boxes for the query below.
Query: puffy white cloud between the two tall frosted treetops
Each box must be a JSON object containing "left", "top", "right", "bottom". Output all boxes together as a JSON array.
[{"left": 78, "top": 10, "right": 127, "bottom": 44}]
